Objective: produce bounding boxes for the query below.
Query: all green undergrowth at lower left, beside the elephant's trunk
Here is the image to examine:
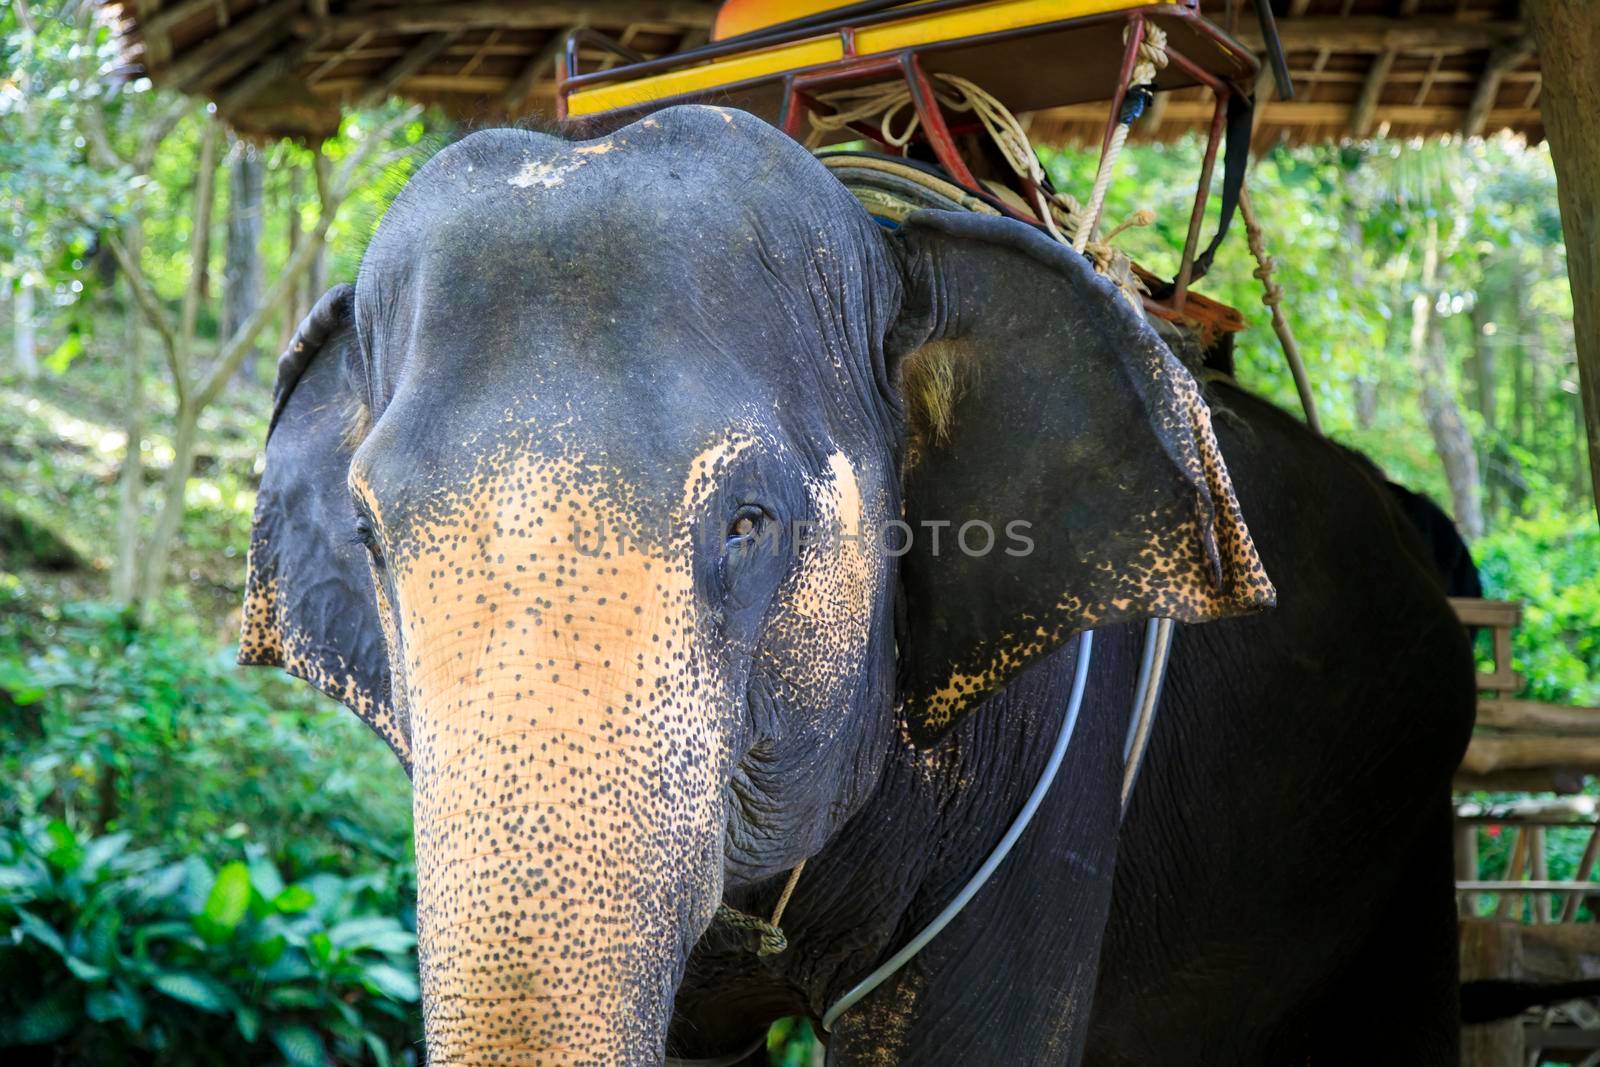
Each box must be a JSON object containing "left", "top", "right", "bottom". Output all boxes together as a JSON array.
[{"left": 0, "top": 573, "right": 421, "bottom": 1067}]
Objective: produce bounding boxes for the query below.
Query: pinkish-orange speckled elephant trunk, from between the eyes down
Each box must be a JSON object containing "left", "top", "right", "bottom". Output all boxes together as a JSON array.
[{"left": 394, "top": 469, "right": 731, "bottom": 1067}]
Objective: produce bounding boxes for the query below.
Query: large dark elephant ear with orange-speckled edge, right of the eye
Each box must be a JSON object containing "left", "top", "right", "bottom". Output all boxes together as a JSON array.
[{"left": 886, "top": 211, "right": 1274, "bottom": 744}]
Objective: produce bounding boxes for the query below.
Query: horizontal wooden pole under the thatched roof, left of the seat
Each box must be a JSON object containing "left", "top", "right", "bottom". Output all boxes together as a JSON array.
[{"left": 296, "top": 0, "right": 717, "bottom": 37}]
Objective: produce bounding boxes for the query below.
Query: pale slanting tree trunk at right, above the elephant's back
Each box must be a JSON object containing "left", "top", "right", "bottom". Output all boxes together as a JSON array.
[{"left": 1411, "top": 219, "right": 1483, "bottom": 541}]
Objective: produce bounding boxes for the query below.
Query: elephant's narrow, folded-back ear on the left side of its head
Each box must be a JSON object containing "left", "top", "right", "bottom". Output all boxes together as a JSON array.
[{"left": 238, "top": 285, "right": 411, "bottom": 768}]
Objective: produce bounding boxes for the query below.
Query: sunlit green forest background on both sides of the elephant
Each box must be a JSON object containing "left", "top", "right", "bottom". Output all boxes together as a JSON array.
[{"left": 0, "top": 0, "right": 1600, "bottom": 1065}]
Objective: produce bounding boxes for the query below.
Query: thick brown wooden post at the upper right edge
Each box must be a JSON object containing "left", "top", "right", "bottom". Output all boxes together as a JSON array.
[{"left": 1523, "top": 0, "right": 1600, "bottom": 524}]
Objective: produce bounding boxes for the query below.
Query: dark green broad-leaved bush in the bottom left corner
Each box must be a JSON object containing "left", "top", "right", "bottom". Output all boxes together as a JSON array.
[{"left": 0, "top": 819, "right": 419, "bottom": 1067}]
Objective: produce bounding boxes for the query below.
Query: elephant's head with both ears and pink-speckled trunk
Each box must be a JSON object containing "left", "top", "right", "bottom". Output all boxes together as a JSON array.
[{"left": 242, "top": 107, "right": 1270, "bottom": 1064}]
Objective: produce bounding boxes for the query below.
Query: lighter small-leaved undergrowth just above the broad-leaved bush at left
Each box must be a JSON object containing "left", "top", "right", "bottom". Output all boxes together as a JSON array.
[{"left": 0, "top": 576, "right": 411, "bottom": 877}]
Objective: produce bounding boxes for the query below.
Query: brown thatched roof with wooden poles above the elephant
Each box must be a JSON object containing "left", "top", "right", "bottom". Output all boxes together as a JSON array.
[{"left": 106, "top": 0, "right": 1544, "bottom": 144}]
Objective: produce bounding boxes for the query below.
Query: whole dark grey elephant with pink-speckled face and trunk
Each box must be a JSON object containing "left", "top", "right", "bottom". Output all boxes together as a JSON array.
[{"left": 240, "top": 106, "right": 1472, "bottom": 1065}]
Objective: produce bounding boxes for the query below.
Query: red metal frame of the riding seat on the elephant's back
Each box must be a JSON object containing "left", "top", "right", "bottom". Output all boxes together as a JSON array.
[{"left": 555, "top": 0, "right": 1258, "bottom": 317}]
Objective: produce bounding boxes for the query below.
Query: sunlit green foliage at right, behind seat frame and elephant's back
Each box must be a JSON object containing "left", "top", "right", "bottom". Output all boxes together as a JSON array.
[{"left": 1040, "top": 138, "right": 1590, "bottom": 528}]
